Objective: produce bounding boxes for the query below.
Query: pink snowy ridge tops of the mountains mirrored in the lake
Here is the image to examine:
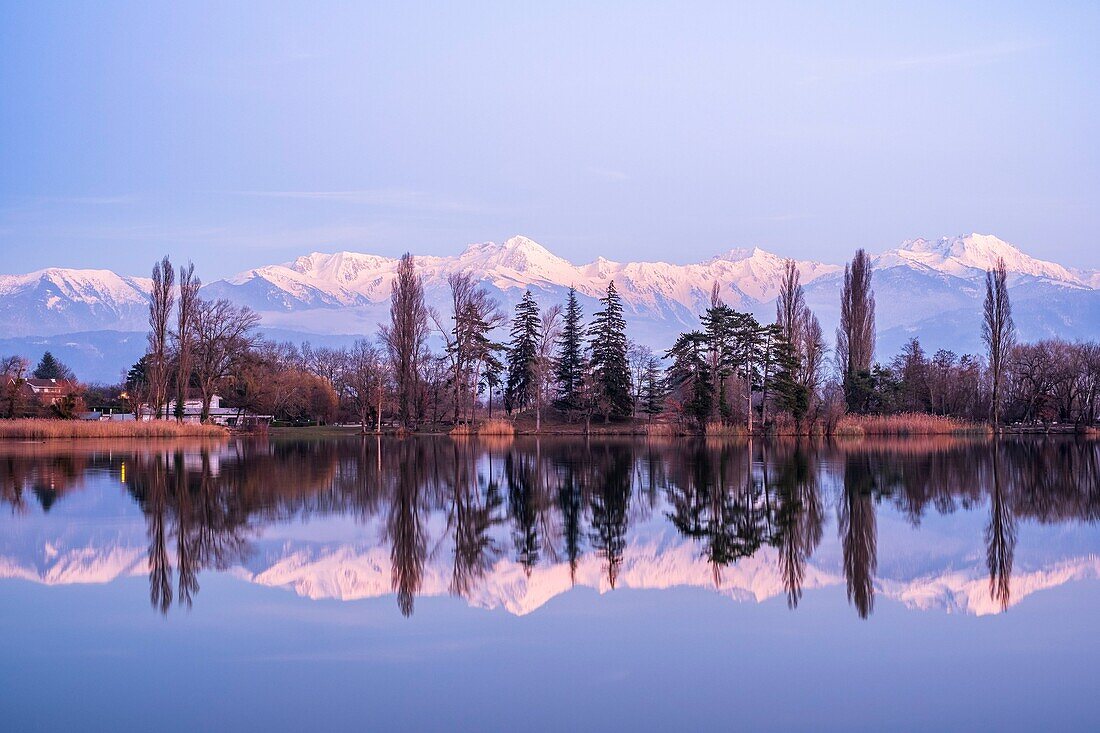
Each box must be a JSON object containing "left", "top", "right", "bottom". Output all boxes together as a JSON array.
[{"left": 0, "top": 536, "right": 1100, "bottom": 616}]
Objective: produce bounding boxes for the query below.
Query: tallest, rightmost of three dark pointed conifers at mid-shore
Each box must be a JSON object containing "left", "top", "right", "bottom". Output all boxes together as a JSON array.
[{"left": 589, "top": 281, "right": 634, "bottom": 420}]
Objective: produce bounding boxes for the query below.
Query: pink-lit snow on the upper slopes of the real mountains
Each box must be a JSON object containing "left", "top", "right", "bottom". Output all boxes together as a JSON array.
[{"left": 0, "top": 233, "right": 1100, "bottom": 323}]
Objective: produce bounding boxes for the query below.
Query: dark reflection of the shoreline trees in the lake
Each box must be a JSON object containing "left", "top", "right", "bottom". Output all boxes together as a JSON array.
[{"left": 0, "top": 438, "right": 1100, "bottom": 617}]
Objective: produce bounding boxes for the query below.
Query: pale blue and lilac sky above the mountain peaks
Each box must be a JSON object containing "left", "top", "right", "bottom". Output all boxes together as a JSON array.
[{"left": 0, "top": 0, "right": 1100, "bottom": 282}]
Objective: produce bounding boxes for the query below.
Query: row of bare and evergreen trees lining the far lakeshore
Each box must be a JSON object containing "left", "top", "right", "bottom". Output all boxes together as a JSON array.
[{"left": 0, "top": 250, "right": 1100, "bottom": 434}]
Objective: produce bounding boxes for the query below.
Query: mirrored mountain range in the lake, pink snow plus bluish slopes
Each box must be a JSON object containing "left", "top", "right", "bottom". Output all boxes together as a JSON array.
[{"left": 0, "top": 501, "right": 1100, "bottom": 616}]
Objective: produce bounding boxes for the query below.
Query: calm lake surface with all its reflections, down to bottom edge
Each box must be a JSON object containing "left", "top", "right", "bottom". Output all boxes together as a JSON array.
[{"left": 0, "top": 438, "right": 1100, "bottom": 731}]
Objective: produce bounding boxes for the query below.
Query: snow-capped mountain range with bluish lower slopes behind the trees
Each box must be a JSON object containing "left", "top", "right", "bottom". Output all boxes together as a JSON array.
[{"left": 0, "top": 233, "right": 1100, "bottom": 383}]
